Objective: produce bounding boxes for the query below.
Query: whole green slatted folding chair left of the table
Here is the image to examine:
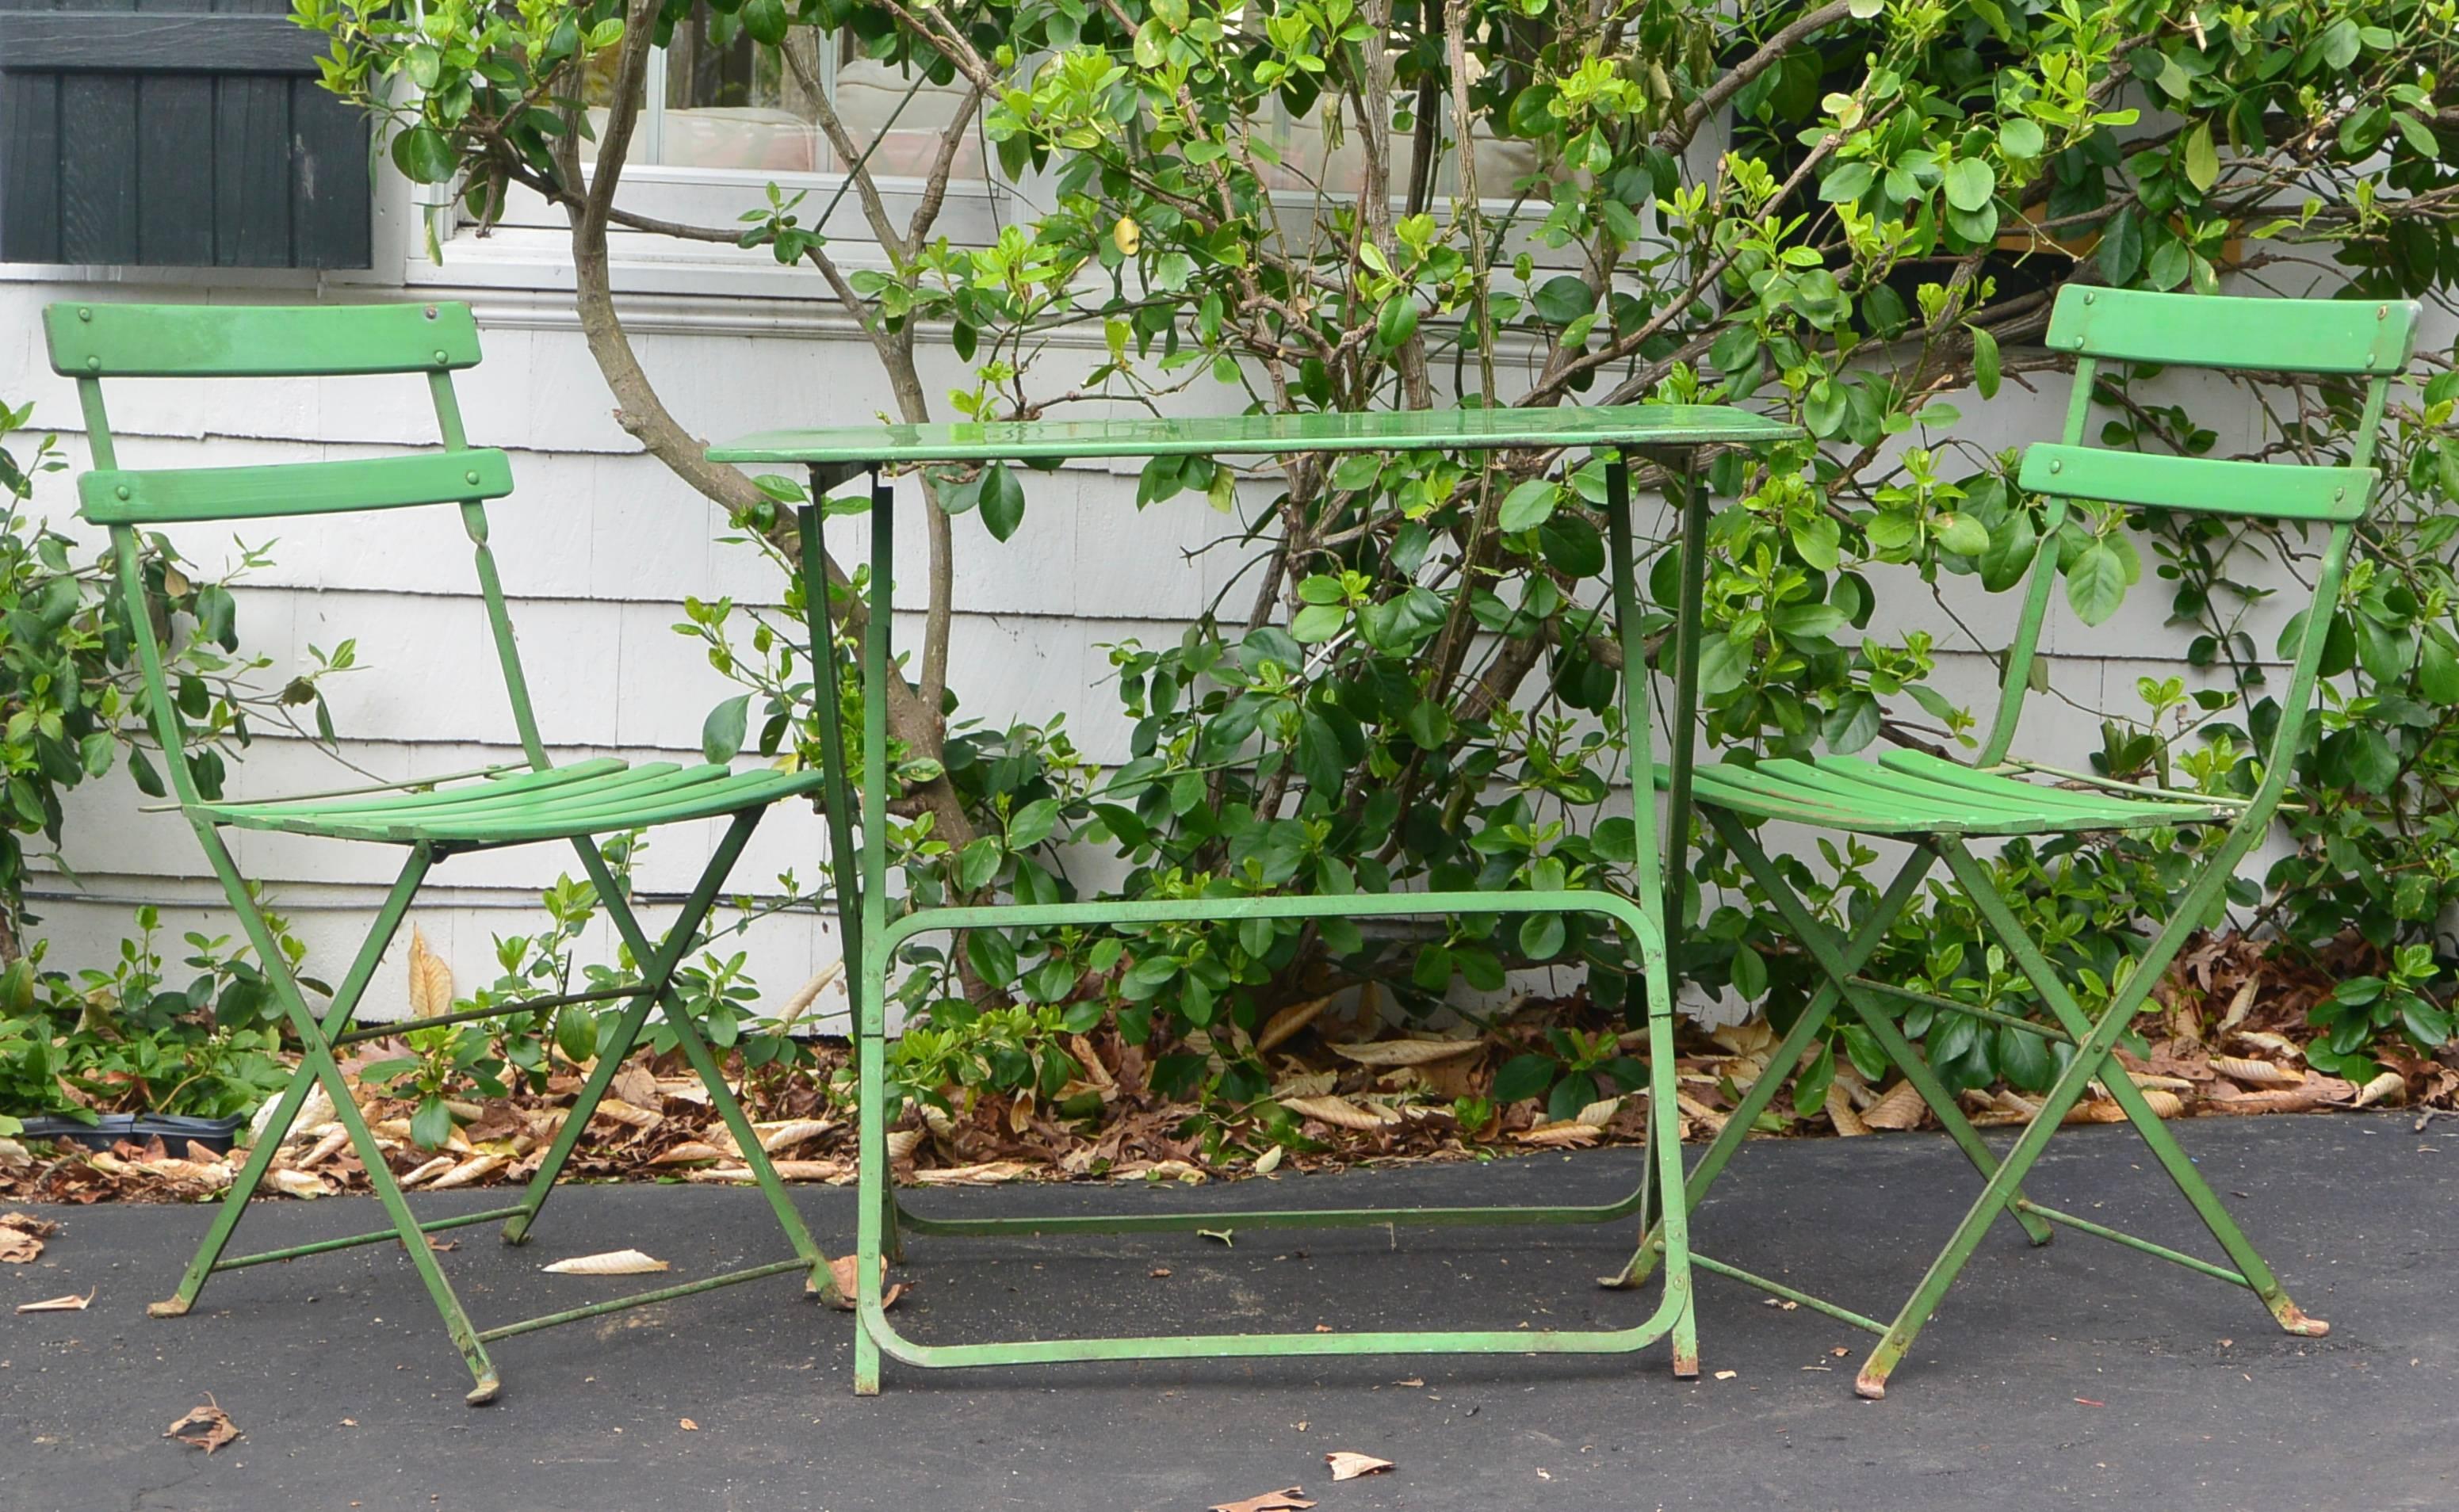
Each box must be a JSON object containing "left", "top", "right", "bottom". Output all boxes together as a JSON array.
[{"left": 44, "top": 305, "right": 836, "bottom": 1403}]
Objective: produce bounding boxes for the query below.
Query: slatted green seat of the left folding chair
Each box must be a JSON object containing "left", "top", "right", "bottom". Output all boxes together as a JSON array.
[{"left": 189, "top": 758, "right": 824, "bottom": 848}]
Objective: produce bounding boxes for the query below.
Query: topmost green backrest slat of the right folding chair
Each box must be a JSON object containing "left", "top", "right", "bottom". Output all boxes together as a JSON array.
[{"left": 2048, "top": 288, "right": 2417, "bottom": 376}]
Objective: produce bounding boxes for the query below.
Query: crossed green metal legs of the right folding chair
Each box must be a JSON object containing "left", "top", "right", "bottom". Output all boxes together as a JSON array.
[{"left": 1616, "top": 809, "right": 2331, "bottom": 1396}]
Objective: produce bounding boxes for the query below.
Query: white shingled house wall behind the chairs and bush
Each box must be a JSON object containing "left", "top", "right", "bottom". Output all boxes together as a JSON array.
[{"left": 0, "top": 181, "right": 2442, "bottom": 1018}]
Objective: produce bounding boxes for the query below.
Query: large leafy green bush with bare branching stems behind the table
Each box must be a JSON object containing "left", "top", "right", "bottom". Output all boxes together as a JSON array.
[{"left": 300, "top": 0, "right": 2459, "bottom": 1125}]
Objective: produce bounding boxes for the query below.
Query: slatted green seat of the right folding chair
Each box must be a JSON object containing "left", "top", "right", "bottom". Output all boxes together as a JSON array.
[{"left": 1658, "top": 750, "right": 2238, "bottom": 836}]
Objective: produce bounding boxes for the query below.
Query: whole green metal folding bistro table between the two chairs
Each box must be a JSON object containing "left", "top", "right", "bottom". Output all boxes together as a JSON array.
[{"left": 708, "top": 406, "right": 1803, "bottom": 1394}]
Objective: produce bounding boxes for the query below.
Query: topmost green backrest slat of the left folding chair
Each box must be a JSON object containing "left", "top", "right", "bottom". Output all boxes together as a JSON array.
[{"left": 42, "top": 303, "right": 477, "bottom": 379}]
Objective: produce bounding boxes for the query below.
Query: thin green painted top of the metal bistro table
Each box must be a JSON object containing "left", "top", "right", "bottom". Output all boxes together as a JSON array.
[{"left": 708, "top": 403, "right": 1803, "bottom": 464}]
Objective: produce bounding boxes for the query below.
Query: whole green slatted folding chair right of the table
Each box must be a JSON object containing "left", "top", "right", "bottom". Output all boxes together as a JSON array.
[{"left": 1623, "top": 288, "right": 2417, "bottom": 1396}]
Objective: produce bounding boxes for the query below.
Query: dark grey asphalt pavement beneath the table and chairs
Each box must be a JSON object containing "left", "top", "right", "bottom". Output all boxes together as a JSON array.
[{"left": 0, "top": 1113, "right": 2459, "bottom": 1512}]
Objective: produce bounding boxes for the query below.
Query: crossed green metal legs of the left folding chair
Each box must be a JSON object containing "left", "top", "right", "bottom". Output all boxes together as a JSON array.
[{"left": 147, "top": 809, "right": 839, "bottom": 1403}]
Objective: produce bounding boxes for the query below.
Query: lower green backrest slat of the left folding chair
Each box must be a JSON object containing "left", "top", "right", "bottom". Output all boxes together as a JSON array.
[{"left": 76, "top": 448, "right": 511, "bottom": 526}]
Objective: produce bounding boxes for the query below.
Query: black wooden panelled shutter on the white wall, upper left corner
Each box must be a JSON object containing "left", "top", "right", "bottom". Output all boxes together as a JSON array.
[{"left": 0, "top": 0, "right": 369, "bottom": 268}]
